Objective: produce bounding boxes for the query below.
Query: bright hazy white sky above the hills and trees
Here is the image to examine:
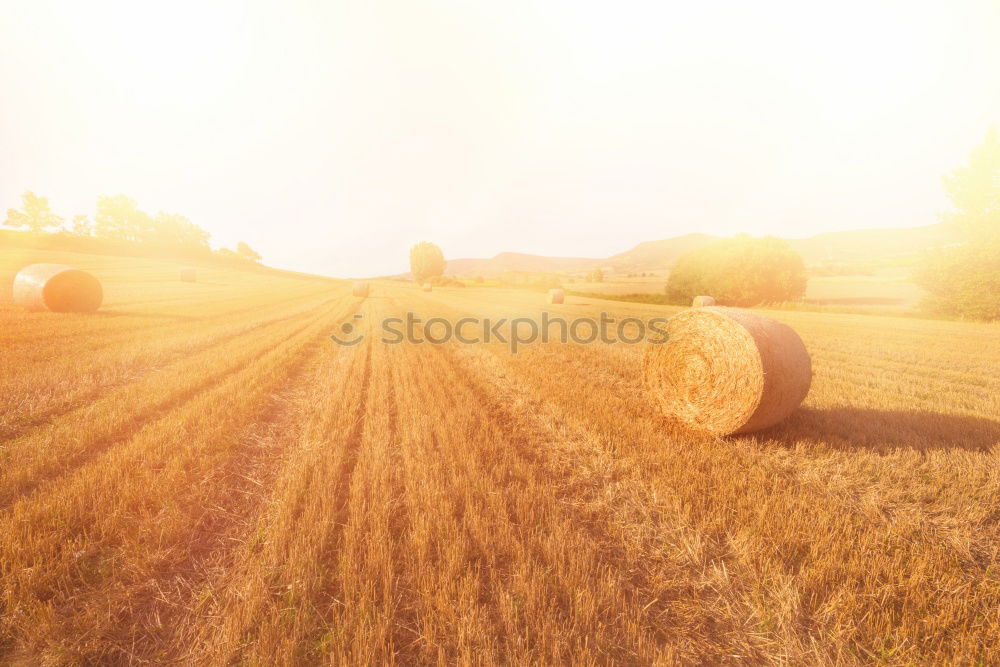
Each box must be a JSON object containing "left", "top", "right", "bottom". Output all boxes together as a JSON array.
[{"left": 0, "top": 0, "right": 1000, "bottom": 276}]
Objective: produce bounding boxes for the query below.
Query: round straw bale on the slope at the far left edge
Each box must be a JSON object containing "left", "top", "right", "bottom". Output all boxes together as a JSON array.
[{"left": 13, "top": 264, "right": 104, "bottom": 313}]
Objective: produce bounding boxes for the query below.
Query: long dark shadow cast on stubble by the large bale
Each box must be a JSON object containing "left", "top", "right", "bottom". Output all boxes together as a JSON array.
[{"left": 761, "top": 407, "right": 1000, "bottom": 451}]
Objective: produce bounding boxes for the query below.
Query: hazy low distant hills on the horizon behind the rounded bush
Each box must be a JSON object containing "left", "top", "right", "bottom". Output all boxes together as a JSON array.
[{"left": 445, "top": 225, "right": 959, "bottom": 276}]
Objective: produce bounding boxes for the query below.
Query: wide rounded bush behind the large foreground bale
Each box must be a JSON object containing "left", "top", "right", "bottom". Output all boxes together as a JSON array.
[{"left": 666, "top": 234, "right": 807, "bottom": 307}]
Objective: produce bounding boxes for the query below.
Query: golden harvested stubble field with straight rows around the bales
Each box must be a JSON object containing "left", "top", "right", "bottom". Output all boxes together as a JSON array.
[{"left": 0, "top": 251, "right": 1000, "bottom": 665}]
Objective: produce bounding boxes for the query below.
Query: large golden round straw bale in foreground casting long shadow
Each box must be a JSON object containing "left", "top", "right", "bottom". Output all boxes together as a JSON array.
[{"left": 644, "top": 306, "right": 812, "bottom": 435}]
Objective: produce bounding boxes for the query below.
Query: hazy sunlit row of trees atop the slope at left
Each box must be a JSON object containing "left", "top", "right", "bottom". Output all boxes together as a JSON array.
[{"left": 3, "top": 191, "right": 262, "bottom": 262}]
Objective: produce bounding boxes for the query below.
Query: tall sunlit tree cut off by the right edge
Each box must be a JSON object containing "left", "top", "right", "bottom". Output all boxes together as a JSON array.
[{"left": 914, "top": 127, "right": 1000, "bottom": 320}]
